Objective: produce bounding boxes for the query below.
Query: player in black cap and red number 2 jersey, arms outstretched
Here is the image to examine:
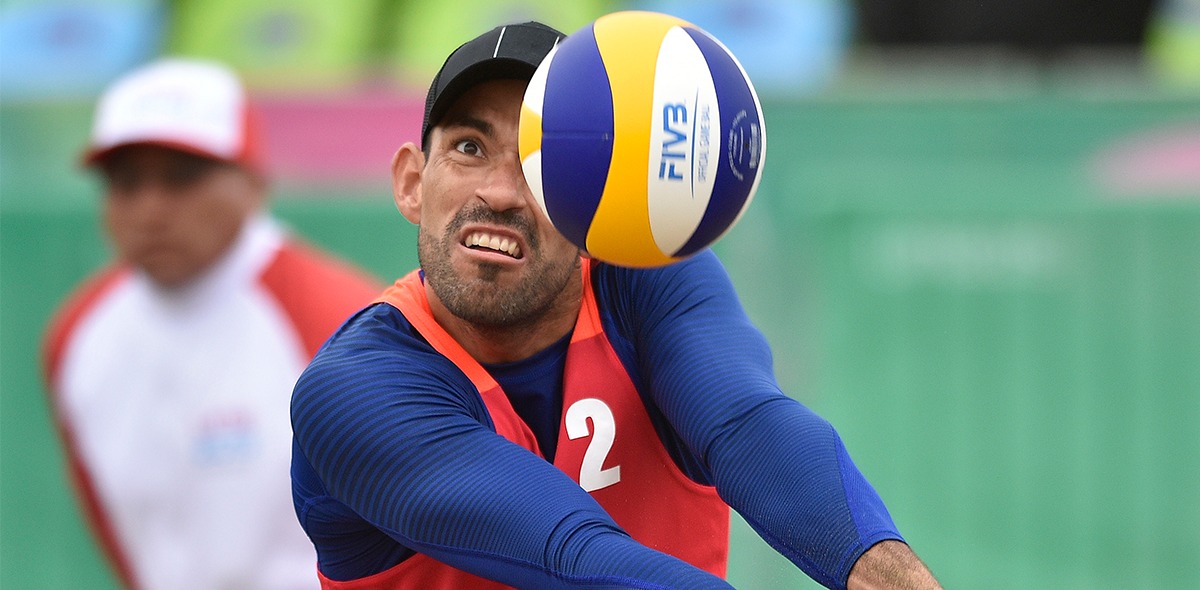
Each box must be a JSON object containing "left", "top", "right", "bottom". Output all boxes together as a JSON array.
[{"left": 292, "top": 23, "right": 938, "bottom": 590}]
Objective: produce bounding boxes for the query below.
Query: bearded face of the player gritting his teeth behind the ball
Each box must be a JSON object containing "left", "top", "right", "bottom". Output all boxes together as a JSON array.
[{"left": 418, "top": 80, "right": 578, "bottom": 327}]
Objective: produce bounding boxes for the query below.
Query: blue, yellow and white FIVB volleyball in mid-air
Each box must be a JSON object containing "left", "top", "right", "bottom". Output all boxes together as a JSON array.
[{"left": 518, "top": 11, "right": 767, "bottom": 267}]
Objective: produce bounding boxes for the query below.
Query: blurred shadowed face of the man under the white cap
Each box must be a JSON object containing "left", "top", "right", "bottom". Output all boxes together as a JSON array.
[{"left": 101, "top": 145, "right": 263, "bottom": 288}]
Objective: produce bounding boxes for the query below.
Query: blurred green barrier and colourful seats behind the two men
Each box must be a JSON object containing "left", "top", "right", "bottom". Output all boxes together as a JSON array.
[{"left": 0, "top": 0, "right": 1200, "bottom": 590}]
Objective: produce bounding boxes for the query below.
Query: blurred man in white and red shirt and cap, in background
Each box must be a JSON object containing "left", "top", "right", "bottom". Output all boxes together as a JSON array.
[{"left": 44, "top": 59, "right": 379, "bottom": 590}]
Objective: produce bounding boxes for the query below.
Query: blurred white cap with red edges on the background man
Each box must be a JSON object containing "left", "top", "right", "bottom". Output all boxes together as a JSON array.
[{"left": 83, "top": 58, "right": 264, "bottom": 173}]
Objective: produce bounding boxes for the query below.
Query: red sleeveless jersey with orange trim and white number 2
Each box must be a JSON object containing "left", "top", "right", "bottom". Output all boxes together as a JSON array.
[{"left": 322, "top": 259, "right": 730, "bottom": 590}]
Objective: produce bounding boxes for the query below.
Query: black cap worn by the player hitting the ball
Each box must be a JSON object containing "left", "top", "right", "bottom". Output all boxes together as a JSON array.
[{"left": 421, "top": 20, "right": 564, "bottom": 148}]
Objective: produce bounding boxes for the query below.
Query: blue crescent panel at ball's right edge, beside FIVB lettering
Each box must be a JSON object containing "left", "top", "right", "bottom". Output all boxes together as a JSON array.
[{"left": 674, "top": 28, "right": 762, "bottom": 257}]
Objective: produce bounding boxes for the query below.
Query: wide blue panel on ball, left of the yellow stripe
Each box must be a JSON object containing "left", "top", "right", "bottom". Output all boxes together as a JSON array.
[{"left": 541, "top": 31, "right": 613, "bottom": 248}]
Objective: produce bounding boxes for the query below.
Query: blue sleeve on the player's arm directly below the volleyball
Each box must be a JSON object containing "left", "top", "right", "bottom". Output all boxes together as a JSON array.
[{"left": 596, "top": 252, "right": 901, "bottom": 588}]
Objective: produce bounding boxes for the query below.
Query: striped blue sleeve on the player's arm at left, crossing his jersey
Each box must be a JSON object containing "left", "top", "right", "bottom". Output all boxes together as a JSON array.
[{"left": 292, "top": 305, "right": 730, "bottom": 589}]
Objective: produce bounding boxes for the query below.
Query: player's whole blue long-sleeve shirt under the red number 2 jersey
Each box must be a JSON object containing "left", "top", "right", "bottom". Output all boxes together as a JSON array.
[{"left": 292, "top": 252, "right": 901, "bottom": 589}]
